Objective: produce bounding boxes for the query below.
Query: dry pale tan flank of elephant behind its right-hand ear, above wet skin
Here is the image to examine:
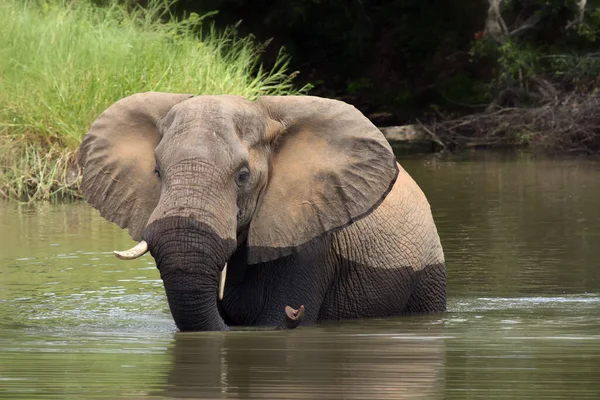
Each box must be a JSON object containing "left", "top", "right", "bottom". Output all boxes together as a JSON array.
[{"left": 335, "top": 166, "right": 444, "bottom": 270}]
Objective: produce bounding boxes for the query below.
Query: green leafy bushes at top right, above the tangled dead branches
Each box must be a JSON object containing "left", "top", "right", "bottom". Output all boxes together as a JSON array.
[{"left": 470, "top": 0, "right": 600, "bottom": 101}]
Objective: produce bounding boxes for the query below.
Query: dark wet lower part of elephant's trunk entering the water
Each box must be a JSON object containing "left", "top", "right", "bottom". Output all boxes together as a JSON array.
[{"left": 145, "top": 217, "right": 236, "bottom": 331}]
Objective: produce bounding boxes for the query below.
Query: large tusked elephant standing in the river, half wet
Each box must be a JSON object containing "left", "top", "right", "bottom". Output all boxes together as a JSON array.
[{"left": 78, "top": 92, "right": 446, "bottom": 331}]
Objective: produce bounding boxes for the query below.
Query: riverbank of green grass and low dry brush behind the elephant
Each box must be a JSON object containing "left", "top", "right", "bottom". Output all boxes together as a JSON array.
[{"left": 0, "top": 0, "right": 600, "bottom": 201}]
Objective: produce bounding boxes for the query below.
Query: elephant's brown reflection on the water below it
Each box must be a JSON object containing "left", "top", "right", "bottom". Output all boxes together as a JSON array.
[{"left": 165, "top": 321, "right": 444, "bottom": 399}]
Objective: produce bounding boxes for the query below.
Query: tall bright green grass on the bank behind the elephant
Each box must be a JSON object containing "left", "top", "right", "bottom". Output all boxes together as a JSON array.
[{"left": 0, "top": 0, "right": 308, "bottom": 200}]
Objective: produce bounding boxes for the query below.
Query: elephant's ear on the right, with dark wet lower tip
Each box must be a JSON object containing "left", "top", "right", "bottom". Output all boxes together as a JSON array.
[{"left": 248, "top": 96, "right": 398, "bottom": 264}]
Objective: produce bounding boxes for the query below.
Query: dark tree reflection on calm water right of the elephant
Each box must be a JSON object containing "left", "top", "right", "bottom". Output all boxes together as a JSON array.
[{"left": 410, "top": 152, "right": 600, "bottom": 296}]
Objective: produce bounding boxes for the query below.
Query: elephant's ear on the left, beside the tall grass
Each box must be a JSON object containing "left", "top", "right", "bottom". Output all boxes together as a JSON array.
[{"left": 78, "top": 92, "right": 192, "bottom": 240}]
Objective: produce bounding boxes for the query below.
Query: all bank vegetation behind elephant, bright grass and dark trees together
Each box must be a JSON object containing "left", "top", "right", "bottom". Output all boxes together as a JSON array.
[{"left": 0, "top": 0, "right": 600, "bottom": 199}]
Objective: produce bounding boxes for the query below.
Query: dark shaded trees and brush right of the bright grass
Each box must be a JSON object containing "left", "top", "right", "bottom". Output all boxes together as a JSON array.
[{"left": 173, "top": 0, "right": 600, "bottom": 153}]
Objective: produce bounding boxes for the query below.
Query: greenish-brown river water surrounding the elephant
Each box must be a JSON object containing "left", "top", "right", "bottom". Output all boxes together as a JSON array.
[{"left": 0, "top": 151, "right": 600, "bottom": 399}]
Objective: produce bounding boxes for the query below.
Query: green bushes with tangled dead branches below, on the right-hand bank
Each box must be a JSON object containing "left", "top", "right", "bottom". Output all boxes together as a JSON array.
[{"left": 429, "top": 0, "right": 600, "bottom": 154}]
